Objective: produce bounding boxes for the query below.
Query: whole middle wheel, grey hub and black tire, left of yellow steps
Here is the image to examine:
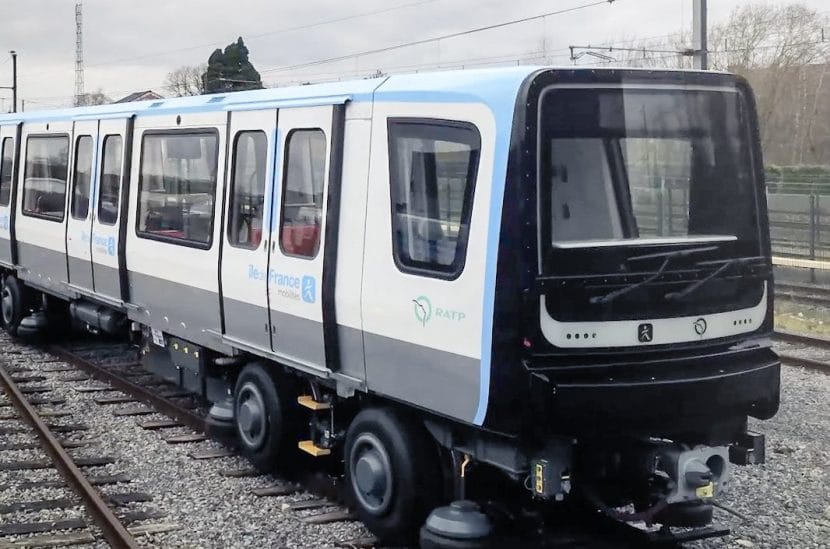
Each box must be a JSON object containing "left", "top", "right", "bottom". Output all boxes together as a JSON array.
[{"left": 234, "top": 363, "right": 294, "bottom": 471}]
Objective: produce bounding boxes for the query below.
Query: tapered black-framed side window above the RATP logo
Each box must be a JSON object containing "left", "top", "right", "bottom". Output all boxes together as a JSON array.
[{"left": 389, "top": 119, "right": 481, "bottom": 279}]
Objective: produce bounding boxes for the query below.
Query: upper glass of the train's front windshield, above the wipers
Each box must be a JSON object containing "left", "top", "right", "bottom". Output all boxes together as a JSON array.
[{"left": 539, "top": 87, "right": 759, "bottom": 250}]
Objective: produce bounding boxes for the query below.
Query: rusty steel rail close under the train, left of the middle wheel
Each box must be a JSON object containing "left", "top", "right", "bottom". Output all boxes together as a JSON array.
[{"left": 48, "top": 345, "right": 207, "bottom": 432}]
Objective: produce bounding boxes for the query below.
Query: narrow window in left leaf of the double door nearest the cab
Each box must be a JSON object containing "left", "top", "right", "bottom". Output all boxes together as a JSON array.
[{"left": 228, "top": 131, "right": 268, "bottom": 250}]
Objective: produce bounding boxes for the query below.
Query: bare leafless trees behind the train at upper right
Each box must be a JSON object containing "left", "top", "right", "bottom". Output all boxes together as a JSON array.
[{"left": 589, "top": 1, "right": 830, "bottom": 164}]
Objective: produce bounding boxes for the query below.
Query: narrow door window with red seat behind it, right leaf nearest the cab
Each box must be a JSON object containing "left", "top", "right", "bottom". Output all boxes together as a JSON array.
[{"left": 280, "top": 129, "right": 326, "bottom": 258}]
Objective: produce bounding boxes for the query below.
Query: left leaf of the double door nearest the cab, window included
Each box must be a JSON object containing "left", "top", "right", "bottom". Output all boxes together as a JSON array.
[{"left": 221, "top": 109, "right": 279, "bottom": 351}]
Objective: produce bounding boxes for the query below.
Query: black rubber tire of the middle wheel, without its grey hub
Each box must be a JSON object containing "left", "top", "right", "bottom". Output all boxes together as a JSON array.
[{"left": 233, "top": 362, "right": 297, "bottom": 472}]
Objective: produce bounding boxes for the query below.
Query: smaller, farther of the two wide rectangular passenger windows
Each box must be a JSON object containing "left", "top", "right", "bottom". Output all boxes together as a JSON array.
[{"left": 23, "top": 135, "right": 69, "bottom": 222}]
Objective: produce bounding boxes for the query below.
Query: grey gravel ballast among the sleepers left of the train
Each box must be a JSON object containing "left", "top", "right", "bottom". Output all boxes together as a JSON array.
[{"left": 0, "top": 334, "right": 370, "bottom": 548}]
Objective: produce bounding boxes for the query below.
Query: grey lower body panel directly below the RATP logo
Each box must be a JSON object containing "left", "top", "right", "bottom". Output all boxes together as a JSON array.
[{"left": 363, "top": 333, "right": 481, "bottom": 422}]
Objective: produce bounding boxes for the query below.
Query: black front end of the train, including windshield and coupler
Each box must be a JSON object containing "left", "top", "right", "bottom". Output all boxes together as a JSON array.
[{"left": 485, "top": 70, "right": 780, "bottom": 527}]
